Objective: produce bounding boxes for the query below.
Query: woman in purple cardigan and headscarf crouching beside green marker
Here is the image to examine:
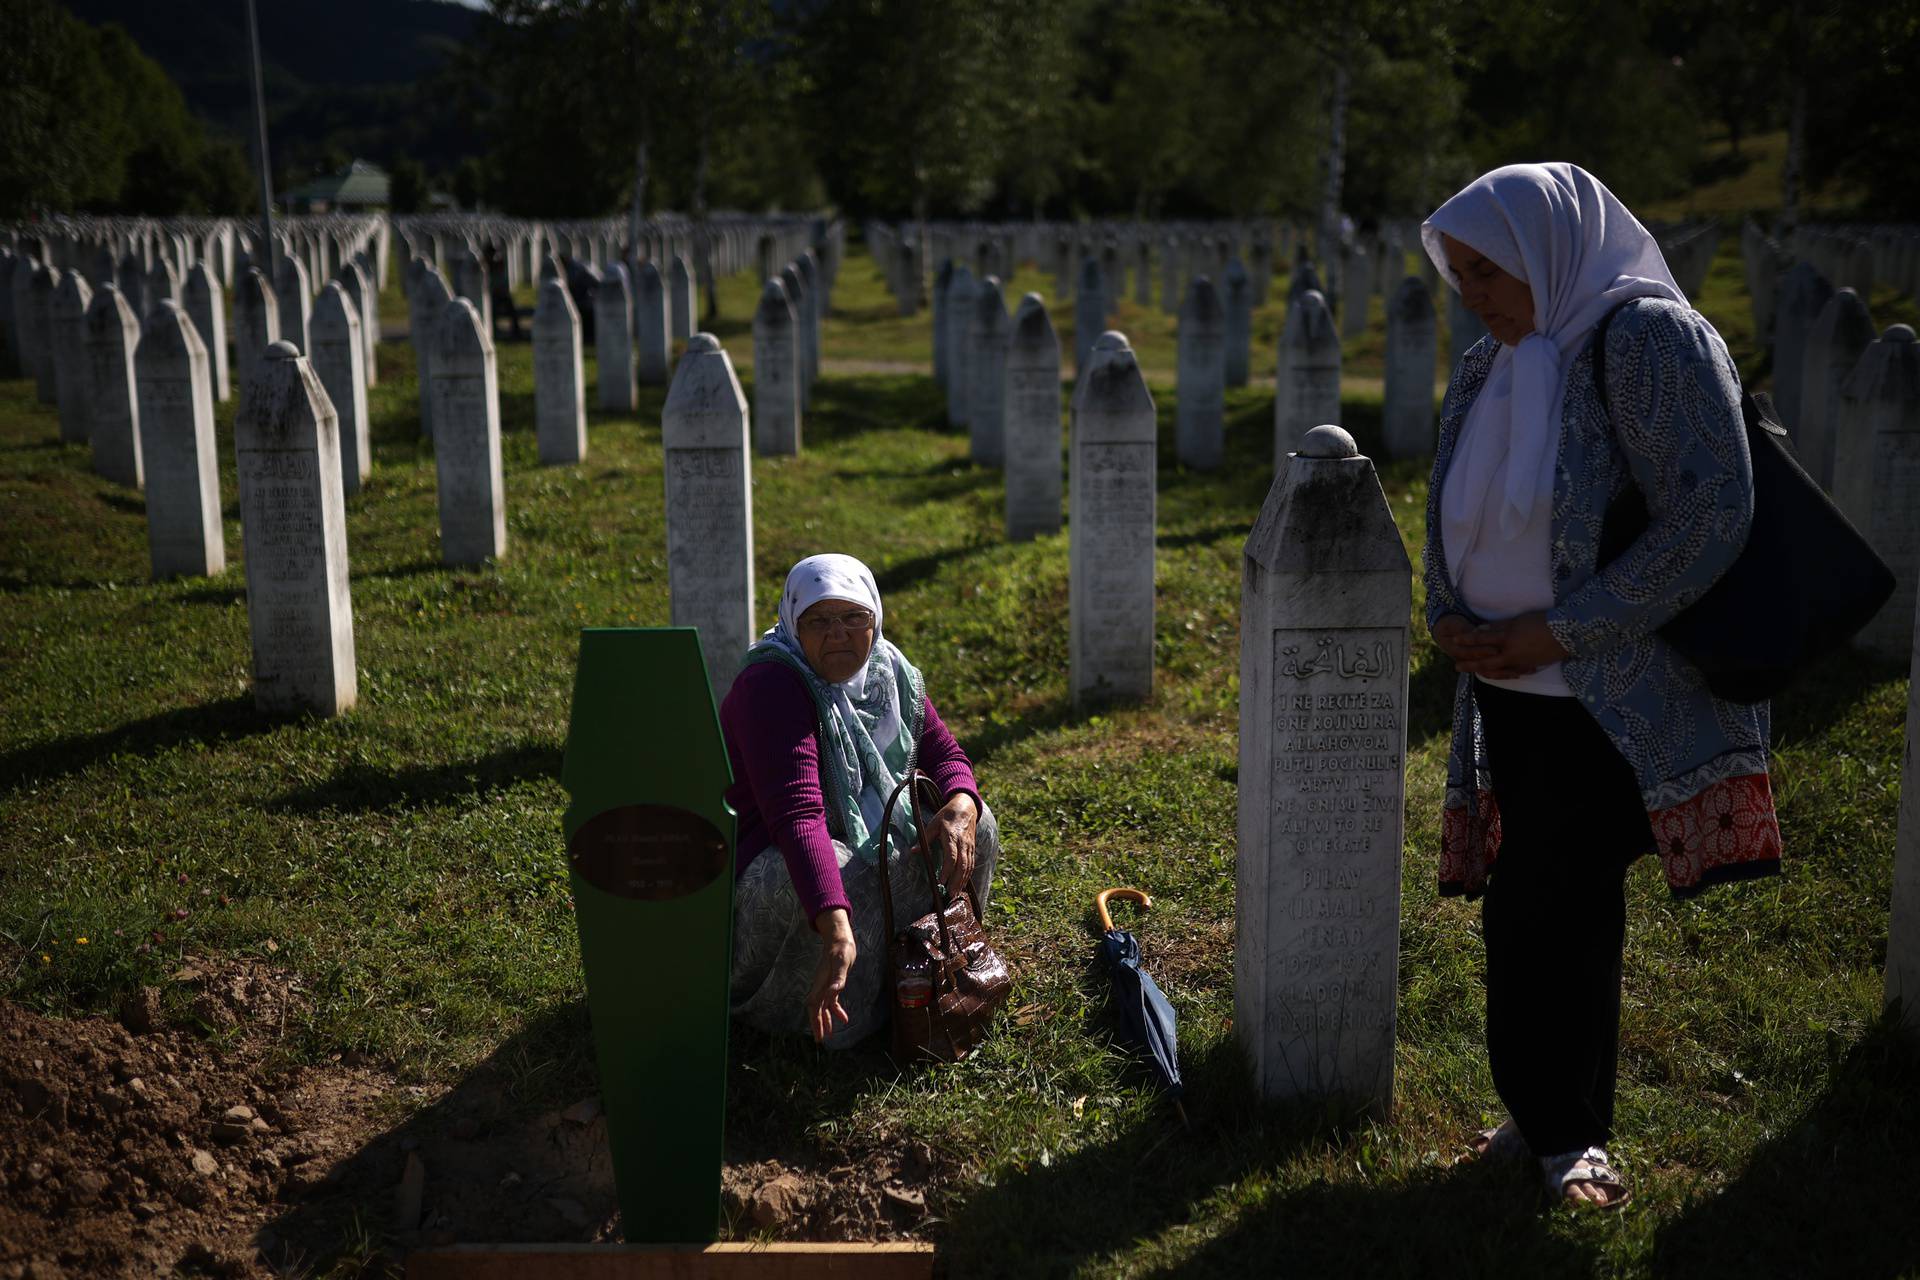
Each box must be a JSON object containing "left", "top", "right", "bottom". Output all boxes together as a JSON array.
[{"left": 720, "top": 555, "right": 1000, "bottom": 1048}]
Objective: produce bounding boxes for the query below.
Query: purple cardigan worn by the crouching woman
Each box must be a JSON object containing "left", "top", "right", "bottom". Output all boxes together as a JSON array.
[{"left": 720, "top": 662, "right": 979, "bottom": 921}]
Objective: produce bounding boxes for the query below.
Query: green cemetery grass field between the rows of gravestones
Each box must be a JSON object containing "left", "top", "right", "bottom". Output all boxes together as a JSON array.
[{"left": 0, "top": 234, "right": 1920, "bottom": 1276}]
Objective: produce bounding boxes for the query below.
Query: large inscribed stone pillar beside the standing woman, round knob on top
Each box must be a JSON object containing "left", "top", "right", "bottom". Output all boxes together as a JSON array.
[{"left": 1233, "top": 426, "right": 1413, "bottom": 1119}]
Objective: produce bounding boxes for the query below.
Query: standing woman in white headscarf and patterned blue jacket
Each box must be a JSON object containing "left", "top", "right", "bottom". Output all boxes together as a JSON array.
[{"left": 1421, "top": 163, "right": 1780, "bottom": 1207}]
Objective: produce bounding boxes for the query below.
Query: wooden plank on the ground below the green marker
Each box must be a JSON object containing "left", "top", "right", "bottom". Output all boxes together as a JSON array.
[{"left": 407, "top": 1242, "right": 933, "bottom": 1280}]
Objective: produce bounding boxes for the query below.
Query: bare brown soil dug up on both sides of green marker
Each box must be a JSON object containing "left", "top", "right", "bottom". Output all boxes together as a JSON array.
[{"left": 0, "top": 961, "right": 939, "bottom": 1280}]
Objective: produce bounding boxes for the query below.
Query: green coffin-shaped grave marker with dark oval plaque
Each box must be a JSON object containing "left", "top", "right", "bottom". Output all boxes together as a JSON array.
[{"left": 561, "top": 628, "right": 733, "bottom": 1244}]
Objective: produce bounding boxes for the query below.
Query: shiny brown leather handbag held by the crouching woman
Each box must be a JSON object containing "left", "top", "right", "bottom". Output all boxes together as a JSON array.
[{"left": 879, "top": 770, "right": 1014, "bottom": 1067}]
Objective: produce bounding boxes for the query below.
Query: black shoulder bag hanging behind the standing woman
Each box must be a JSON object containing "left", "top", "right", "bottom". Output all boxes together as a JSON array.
[{"left": 1594, "top": 303, "right": 1893, "bottom": 702}]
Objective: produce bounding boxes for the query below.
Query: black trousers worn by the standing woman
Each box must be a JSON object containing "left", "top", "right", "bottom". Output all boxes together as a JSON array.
[{"left": 1475, "top": 681, "right": 1653, "bottom": 1155}]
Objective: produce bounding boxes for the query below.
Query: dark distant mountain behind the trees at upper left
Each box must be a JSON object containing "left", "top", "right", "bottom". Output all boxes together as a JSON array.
[{"left": 65, "top": 0, "right": 493, "bottom": 178}]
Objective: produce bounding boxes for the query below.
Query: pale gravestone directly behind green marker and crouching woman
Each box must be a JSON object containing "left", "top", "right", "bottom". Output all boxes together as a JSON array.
[{"left": 660, "top": 334, "right": 755, "bottom": 700}]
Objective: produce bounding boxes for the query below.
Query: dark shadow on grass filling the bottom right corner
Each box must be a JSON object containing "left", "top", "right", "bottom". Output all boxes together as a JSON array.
[{"left": 1651, "top": 1025, "right": 1920, "bottom": 1280}]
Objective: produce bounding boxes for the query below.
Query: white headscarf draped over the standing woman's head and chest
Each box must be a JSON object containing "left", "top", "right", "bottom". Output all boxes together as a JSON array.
[{"left": 1421, "top": 163, "right": 1686, "bottom": 572}]
